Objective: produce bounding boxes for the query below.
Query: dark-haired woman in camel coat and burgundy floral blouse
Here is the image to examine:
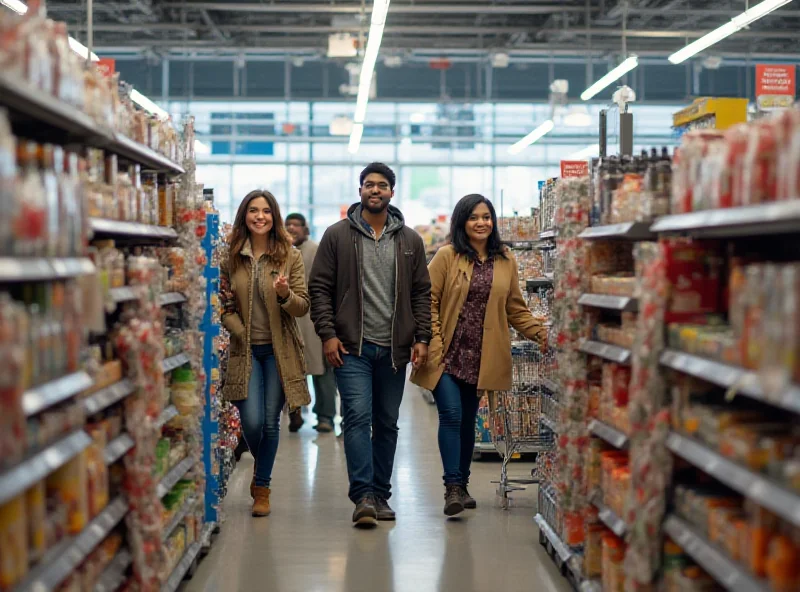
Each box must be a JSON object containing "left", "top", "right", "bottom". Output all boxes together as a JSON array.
[{"left": 411, "top": 194, "right": 547, "bottom": 516}]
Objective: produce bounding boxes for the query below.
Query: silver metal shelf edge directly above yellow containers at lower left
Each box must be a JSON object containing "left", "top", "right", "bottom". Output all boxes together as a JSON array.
[{"left": 0, "top": 428, "right": 92, "bottom": 504}]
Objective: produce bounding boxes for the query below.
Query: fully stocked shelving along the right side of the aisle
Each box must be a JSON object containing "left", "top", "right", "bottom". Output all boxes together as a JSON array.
[{"left": 540, "top": 110, "right": 800, "bottom": 592}]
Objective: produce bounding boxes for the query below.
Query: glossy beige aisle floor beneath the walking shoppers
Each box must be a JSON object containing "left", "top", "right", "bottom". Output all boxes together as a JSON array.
[{"left": 182, "top": 384, "right": 570, "bottom": 592}]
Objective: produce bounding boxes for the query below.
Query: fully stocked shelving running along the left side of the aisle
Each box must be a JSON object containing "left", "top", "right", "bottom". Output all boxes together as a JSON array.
[{"left": 0, "top": 2, "right": 219, "bottom": 591}]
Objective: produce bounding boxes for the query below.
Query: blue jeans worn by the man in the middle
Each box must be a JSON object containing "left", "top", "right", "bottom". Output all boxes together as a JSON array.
[{"left": 336, "top": 342, "right": 406, "bottom": 503}]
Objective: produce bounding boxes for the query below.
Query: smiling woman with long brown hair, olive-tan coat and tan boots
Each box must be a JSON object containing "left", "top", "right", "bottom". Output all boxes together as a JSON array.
[{"left": 219, "top": 190, "right": 311, "bottom": 516}]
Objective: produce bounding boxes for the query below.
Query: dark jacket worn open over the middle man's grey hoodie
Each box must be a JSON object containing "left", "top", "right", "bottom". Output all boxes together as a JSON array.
[{"left": 309, "top": 204, "right": 431, "bottom": 368}]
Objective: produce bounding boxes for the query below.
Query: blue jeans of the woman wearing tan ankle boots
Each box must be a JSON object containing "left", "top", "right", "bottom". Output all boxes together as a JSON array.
[{"left": 235, "top": 344, "right": 286, "bottom": 487}]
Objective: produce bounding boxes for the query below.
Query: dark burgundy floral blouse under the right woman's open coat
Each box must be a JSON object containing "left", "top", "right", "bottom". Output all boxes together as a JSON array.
[{"left": 444, "top": 259, "right": 494, "bottom": 384}]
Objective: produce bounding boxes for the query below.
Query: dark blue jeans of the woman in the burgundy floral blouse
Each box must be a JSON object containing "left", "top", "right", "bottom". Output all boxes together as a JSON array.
[{"left": 433, "top": 373, "right": 479, "bottom": 485}]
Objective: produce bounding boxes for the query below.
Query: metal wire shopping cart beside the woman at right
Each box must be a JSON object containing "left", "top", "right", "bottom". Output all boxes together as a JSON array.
[{"left": 488, "top": 341, "right": 553, "bottom": 509}]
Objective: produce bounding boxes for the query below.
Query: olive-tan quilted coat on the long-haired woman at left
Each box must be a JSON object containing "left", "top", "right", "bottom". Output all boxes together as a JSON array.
[{"left": 220, "top": 241, "right": 311, "bottom": 409}]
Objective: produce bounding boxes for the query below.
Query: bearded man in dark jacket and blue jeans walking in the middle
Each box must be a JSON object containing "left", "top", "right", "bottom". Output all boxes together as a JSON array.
[{"left": 309, "top": 163, "right": 431, "bottom": 526}]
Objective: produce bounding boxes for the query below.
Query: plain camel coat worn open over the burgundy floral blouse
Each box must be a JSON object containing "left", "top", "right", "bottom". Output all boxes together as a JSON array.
[{"left": 411, "top": 245, "right": 547, "bottom": 391}]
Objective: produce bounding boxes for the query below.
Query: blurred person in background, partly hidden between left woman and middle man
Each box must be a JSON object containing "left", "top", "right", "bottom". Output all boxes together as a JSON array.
[{"left": 286, "top": 214, "right": 336, "bottom": 433}]
